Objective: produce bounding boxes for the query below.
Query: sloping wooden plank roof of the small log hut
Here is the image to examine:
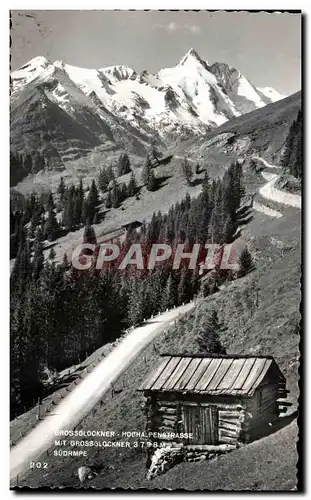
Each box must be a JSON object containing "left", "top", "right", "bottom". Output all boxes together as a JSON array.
[{"left": 138, "top": 355, "right": 284, "bottom": 396}]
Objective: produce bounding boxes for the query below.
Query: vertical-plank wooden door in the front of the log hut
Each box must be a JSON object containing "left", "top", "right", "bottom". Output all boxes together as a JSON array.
[{"left": 182, "top": 405, "right": 218, "bottom": 444}]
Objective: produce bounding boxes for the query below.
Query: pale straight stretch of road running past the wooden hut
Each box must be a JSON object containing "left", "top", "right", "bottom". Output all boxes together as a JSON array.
[{"left": 10, "top": 302, "right": 194, "bottom": 481}]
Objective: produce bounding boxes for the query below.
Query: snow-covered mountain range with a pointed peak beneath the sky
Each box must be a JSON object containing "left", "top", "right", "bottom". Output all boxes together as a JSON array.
[{"left": 11, "top": 49, "right": 284, "bottom": 170}]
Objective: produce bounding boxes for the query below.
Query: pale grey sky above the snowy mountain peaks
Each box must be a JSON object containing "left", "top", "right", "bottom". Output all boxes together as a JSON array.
[{"left": 11, "top": 10, "right": 301, "bottom": 95}]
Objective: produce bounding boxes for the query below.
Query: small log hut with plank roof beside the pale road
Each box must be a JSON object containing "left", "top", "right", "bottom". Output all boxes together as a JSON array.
[{"left": 138, "top": 354, "right": 287, "bottom": 447}]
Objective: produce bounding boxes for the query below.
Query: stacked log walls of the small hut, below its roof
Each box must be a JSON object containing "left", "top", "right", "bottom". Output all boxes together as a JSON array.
[{"left": 145, "top": 382, "right": 285, "bottom": 445}]
